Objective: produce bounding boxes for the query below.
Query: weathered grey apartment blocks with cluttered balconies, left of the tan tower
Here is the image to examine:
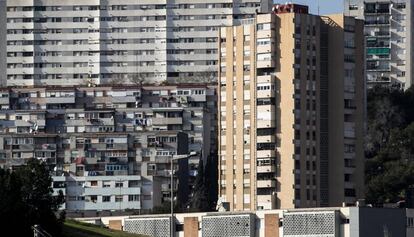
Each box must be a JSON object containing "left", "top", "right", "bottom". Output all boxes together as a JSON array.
[{"left": 0, "top": 84, "right": 217, "bottom": 210}]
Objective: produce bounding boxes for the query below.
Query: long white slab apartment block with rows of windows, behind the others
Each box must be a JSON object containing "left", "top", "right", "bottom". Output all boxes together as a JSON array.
[{"left": 0, "top": 0, "right": 272, "bottom": 86}]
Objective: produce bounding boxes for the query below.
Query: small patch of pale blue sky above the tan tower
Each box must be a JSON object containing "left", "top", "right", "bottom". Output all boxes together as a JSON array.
[{"left": 274, "top": 0, "right": 344, "bottom": 15}]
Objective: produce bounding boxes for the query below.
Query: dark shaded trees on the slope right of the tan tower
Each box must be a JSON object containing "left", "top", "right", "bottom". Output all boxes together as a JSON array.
[{"left": 365, "top": 87, "right": 414, "bottom": 206}]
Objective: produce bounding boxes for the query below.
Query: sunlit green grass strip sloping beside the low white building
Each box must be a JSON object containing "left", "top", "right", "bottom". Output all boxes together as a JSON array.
[{"left": 62, "top": 220, "right": 144, "bottom": 237}]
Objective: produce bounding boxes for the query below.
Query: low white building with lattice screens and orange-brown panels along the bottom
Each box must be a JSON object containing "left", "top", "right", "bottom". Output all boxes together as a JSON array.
[{"left": 78, "top": 207, "right": 413, "bottom": 237}]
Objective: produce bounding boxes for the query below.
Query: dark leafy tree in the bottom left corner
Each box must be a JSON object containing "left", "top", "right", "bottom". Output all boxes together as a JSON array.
[{"left": 0, "top": 159, "right": 64, "bottom": 236}]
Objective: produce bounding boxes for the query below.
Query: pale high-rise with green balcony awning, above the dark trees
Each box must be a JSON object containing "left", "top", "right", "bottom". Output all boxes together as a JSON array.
[{"left": 344, "top": 0, "right": 414, "bottom": 89}]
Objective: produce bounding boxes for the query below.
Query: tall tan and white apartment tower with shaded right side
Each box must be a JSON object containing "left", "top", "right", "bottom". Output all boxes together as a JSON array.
[{"left": 218, "top": 6, "right": 365, "bottom": 210}]
